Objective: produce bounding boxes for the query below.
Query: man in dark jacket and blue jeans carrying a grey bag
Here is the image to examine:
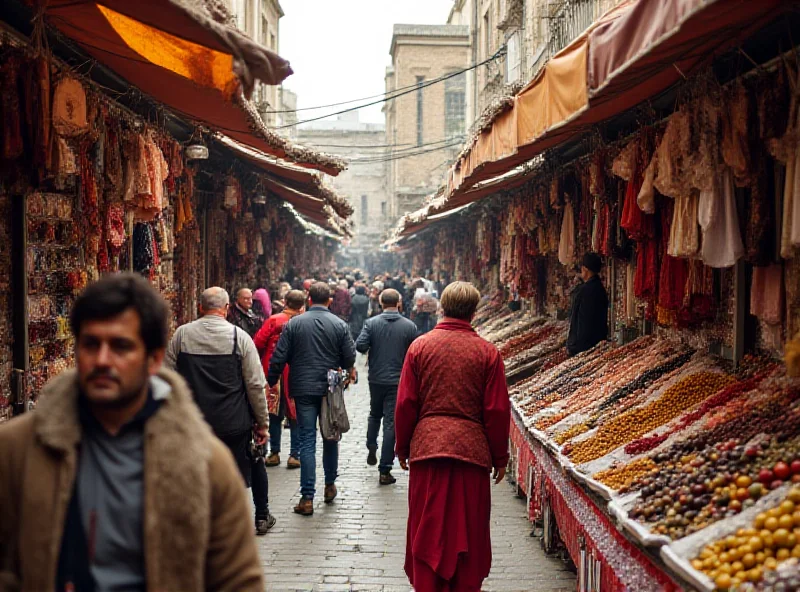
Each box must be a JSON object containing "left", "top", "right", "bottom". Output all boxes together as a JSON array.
[{"left": 267, "top": 282, "right": 356, "bottom": 516}]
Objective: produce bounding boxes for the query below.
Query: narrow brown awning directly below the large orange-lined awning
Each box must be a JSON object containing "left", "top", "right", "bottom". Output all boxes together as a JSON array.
[{"left": 214, "top": 134, "right": 353, "bottom": 218}]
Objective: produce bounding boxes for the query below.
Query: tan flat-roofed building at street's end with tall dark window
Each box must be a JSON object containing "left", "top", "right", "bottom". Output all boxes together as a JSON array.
[{"left": 384, "top": 24, "right": 471, "bottom": 219}]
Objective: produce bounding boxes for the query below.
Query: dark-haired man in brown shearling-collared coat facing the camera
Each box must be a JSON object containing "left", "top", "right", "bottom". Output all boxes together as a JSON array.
[{"left": 0, "top": 274, "right": 264, "bottom": 591}]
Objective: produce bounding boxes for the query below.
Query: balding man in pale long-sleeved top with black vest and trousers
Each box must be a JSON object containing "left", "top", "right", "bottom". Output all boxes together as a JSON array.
[{"left": 166, "top": 287, "right": 275, "bottom": 535}]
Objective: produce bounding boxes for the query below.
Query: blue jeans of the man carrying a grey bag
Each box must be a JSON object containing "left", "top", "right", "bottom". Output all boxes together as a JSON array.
[{"left": 294, "top": 397, "right": 339, "bottom": 499}]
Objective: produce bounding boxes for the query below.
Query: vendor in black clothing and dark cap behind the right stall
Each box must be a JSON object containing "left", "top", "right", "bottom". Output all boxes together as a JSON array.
[{"left": 567, "top": 253, "right": 608, "bottom": 356}]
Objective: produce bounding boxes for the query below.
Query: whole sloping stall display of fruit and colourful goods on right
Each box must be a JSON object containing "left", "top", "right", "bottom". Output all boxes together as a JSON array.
[{"left": 472, "top": 302, "right": 800, "bottom": 590}]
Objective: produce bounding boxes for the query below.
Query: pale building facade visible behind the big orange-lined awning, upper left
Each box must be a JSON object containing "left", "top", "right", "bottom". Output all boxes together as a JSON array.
[{"left": 227, "top": 0, "right": 284, "bottom": 126}]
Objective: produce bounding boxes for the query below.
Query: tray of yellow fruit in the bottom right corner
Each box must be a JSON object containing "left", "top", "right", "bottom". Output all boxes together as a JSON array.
[{"left": 692, "top": 487, "right": 800, "bottom": 592}]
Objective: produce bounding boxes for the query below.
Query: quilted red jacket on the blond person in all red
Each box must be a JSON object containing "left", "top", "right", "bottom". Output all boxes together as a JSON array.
[{"left": 395, "top": 318, "right": 511, "bottom": 469}]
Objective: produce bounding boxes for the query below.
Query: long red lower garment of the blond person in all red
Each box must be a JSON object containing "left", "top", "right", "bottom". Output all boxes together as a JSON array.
[{"left": 405, "top": 458, "right": 492, "bottom": 592}]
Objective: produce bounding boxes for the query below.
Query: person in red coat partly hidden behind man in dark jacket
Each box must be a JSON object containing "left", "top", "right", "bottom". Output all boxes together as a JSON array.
[{"left": 253, "top": 290, "right": 306, "bottom": 469}]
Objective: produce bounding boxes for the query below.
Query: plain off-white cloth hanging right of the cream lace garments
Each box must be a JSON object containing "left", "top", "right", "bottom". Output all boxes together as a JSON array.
[{"left": 697, "top": 169, "right": 744, "bottom": 267}]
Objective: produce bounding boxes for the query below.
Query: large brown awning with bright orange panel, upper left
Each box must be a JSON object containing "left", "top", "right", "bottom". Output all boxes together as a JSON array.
[{"left": 40, "top": 0, "right": 344, "bottom": 175}]
